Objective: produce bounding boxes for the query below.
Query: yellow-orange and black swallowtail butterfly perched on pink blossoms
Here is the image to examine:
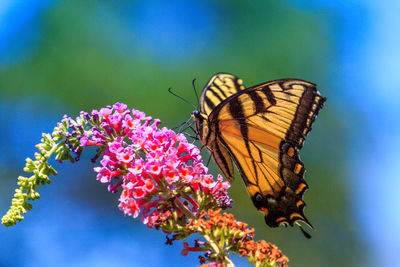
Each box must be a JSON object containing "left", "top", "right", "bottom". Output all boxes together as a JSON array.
[{"left": 192, "top": 73, "right": 326, "bottom": 237}]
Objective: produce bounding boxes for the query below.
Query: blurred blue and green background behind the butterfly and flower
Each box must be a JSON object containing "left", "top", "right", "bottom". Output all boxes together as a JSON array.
[{"left": 0, "top": 0, "right": 400, "bottom": 266}]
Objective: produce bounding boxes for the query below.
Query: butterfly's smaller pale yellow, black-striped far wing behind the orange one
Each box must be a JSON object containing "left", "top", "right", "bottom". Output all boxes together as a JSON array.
[{"left": 200, "top": 73, "right": 245, "bottom": 116}]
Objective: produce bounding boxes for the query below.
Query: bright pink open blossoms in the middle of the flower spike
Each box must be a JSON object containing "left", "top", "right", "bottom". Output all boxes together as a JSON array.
[{"left": 79, "top": 103, "right": 231, "bottom": 226}]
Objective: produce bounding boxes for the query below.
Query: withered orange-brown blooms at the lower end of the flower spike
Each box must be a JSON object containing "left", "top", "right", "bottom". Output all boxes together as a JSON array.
[{"left": 181, "top": 209, "right": 289, "bottom": 267}]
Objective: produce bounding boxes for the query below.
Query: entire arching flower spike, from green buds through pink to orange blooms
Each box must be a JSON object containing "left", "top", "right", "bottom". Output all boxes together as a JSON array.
[{"left": 2, "top": 103, "right": 286, "bottom": 266}]
